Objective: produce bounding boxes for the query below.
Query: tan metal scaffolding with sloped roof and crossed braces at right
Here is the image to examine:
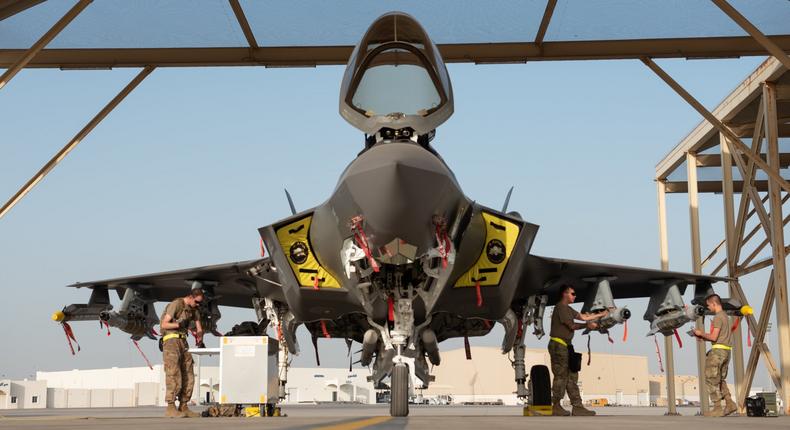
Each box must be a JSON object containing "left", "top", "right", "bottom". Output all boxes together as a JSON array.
[{"left": 656, "top": 57, "right": 790, "bottom": 413}]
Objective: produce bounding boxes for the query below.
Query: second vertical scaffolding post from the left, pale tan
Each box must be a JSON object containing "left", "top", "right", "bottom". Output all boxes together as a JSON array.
[{"left": 686, "top": 152, "right": 709, "bottom": 412}]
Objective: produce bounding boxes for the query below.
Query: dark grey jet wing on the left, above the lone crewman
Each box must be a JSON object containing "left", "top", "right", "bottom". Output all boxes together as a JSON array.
[{"left": 69, "top": 258, "right": 279, "bottom": 308}]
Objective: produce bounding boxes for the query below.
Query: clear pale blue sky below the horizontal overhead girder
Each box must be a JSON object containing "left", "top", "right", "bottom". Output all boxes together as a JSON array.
[{"left": 0, "top": 43, "right": 774, "bottom": 386}]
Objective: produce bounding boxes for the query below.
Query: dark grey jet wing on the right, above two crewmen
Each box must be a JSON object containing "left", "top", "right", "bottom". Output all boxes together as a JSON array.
[{"left": 521, "top": 255, "right": 728, "bottom": 303}]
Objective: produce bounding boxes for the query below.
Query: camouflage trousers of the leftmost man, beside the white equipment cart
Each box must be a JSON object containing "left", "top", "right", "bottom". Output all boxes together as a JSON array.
[{"left": 163, "top": 339, "right": 195, "bottom": 404}]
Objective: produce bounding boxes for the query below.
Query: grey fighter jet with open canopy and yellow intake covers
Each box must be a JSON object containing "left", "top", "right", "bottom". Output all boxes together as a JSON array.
[{"left": 55, "top": 12, "right": 736, "bottom": 416}]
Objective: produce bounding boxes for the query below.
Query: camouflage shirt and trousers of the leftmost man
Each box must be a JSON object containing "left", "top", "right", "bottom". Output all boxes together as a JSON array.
[{"left": 162, "top": 298, "right": 200, "bottom": 404}]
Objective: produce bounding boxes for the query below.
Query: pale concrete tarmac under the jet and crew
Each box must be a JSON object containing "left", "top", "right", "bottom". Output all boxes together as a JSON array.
[{"left": 0, "top": 404, "right": 790, "bottom": 430}]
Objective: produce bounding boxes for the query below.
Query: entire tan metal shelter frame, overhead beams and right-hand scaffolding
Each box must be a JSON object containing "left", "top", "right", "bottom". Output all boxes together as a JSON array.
[{"left": 0, "top": 0, "right": 790, "bottom": 414}]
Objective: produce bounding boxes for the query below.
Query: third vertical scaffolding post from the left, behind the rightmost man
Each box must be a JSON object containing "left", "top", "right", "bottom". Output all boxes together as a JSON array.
[{"left": 719, "top": 133, "right": 749, "bottom": 413}]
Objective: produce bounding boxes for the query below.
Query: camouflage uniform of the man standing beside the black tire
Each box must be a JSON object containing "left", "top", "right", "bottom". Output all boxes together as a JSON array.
[{"left": 549, "top": 303, "right": 582, "bottom": 407}]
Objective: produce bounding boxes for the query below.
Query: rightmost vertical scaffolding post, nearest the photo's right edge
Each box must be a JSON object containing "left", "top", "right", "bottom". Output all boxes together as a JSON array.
[{"left": 763, "top": 82, "right": 790, "bottom": 415}]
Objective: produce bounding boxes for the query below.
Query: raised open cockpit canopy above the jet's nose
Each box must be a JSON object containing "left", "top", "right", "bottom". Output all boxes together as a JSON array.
[{"left": 340, "top": 12, "right": 453, "bottom": 135}]
